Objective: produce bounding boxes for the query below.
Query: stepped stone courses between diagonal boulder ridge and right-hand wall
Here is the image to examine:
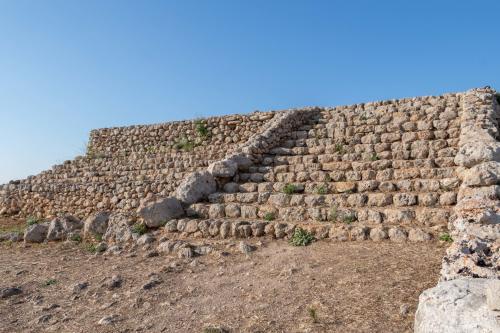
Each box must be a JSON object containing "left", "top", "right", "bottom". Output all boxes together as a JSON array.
[{"left": 190, "top": 94, "right": 462, "bottom": 237}]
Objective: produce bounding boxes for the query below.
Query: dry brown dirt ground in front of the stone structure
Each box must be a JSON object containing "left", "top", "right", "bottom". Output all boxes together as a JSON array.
[{"left": 0, "top": 218, "right": 447, "bottom": 333}]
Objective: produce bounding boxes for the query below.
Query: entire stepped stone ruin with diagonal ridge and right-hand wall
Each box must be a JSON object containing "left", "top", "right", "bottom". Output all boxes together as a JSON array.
[{"left": 0, "top": 87, "right": 500, "bottom": 332}]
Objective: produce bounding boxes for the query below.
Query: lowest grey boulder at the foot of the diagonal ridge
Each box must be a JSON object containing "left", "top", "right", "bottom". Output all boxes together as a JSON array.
[{"left": 139, "top": 197, "right": 184, "bottom": 228}]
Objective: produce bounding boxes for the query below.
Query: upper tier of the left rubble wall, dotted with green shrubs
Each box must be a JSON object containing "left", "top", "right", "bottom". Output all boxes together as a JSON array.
[{"left": 87, "top": 112, "right": 274, "bottom": 158}]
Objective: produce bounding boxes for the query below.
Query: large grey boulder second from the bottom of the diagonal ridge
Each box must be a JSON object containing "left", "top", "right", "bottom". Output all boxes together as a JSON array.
[{"left": 175, "top": 171, "right": 217, "bottom": 205}]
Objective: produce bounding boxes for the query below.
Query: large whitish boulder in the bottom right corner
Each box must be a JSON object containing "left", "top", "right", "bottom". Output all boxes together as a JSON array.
[{"left": 415, "top": 279, "right": 500, "bottom": 333}]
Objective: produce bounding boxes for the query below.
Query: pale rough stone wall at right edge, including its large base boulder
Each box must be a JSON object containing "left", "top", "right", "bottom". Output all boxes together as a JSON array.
[{"left": 415, "top": 87, "right": 500, "bottom": 333}]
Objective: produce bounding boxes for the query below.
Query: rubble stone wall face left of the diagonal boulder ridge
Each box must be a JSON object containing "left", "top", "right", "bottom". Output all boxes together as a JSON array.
[{"left": 0, "top": 112, "right": 275, "bottom": 218}]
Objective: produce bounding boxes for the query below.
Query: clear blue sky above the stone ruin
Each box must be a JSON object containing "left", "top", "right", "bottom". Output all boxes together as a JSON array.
[{"left": 0, "top": 0, "right": 500, "bottom": 183}]
